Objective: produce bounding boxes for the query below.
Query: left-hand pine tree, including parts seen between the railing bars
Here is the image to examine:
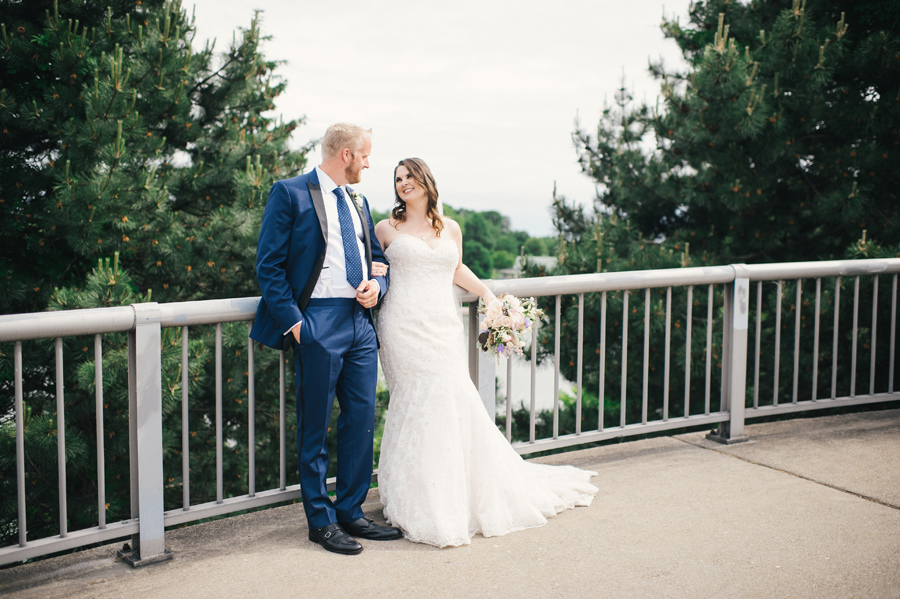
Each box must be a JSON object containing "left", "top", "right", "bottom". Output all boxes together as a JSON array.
[{"left": 0, "top": 0, "right": 309, "bottom": 544}]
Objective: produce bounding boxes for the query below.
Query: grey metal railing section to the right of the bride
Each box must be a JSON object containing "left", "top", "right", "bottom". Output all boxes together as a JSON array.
[{"left": 462, "top": 258, "right": 900, "bottom": 455}]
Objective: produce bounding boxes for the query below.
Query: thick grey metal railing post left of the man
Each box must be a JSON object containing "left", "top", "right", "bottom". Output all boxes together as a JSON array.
[{"left": 119, "top": 302, "right": 173, "bottom": 567}]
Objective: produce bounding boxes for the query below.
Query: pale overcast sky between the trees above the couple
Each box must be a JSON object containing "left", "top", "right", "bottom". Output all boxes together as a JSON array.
[{"left": 183, "top": 0, "right": 689, "bottom": 236}]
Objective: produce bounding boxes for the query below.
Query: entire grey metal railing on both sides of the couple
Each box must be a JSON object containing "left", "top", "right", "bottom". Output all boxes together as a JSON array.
[{"left": 0, "top": 259, "right": 900, "bottom": 565}]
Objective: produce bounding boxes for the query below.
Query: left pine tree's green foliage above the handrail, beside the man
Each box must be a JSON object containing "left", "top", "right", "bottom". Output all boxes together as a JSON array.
[{"left": 0, "top": 0, "right": 305, "bottom": 313}]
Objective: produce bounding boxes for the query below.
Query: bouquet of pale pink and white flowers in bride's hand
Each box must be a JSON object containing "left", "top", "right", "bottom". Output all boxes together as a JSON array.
[{"left": 478, "top": 293, "right": 544, "bottom": 359}]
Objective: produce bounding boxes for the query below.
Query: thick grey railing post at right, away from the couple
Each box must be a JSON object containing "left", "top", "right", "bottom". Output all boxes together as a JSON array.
[{"left": 707, "top": 264, "right": 750, "bottom": 444}]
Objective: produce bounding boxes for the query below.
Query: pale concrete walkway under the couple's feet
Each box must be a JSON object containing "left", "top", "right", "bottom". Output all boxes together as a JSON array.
[{"left": 0, "top": 410, "right": 900, "bottom": 599}]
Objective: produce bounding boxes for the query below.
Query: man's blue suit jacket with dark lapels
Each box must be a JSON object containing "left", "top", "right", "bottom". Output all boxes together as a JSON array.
[{"left": 250, "top": 170, "right": 388, "bottom": 349}]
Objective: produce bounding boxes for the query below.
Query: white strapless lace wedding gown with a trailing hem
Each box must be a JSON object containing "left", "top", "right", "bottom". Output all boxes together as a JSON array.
[{"left": 378, "top": 235, "right": 597, "bottom": 547}]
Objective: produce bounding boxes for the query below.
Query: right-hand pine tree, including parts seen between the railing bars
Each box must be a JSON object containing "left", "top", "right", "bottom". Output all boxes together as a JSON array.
[{"left": 512, "top": 0, "right": 900, "bottom": 440}]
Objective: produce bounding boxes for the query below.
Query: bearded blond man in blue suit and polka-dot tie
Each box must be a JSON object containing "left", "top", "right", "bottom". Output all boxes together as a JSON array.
[{"left": 250, "top": 123, "right": 403, "bottom": 555}]
